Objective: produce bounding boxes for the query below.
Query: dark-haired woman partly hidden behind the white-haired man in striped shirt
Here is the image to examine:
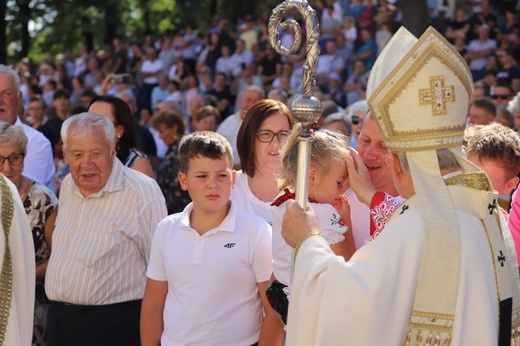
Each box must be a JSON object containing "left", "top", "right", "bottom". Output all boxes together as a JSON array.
[{"left": 88, "top": 95, "right": 154, "bottom": 178}]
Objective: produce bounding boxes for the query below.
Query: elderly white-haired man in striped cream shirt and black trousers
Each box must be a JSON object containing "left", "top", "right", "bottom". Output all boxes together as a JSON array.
[{"left": 45, "top": 113, "right": 167, "bottom": 346}]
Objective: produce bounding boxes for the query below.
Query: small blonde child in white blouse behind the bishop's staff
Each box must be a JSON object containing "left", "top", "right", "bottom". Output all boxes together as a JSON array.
[{"left": 262, "top": 124, "right": 352, "bottom": 344}]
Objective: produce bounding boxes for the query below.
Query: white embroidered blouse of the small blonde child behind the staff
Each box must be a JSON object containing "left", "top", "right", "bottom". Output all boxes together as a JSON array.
[{"left": 272, "top": 199, "right": 347, "bottom": 286}]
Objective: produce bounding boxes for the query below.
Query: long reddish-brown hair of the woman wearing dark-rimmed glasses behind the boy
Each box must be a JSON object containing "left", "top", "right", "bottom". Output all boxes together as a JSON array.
[{"left": 237, "top": 99, "right": 295, "bottom": 177}]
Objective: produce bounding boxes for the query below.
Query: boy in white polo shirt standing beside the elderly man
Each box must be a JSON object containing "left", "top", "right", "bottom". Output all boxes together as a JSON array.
[{"left": 141, "top": 131, "right": 272, "bottom": 346}]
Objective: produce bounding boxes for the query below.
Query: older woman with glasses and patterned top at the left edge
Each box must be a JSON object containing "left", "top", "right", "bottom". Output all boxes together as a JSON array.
[{"left": 0, "top": 121, "right": 58, "bottom": 345}]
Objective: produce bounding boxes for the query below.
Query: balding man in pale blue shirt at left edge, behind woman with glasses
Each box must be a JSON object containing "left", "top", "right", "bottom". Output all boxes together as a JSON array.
[{"left": 0, "top": 65, "right": 56, "bottom": 186}]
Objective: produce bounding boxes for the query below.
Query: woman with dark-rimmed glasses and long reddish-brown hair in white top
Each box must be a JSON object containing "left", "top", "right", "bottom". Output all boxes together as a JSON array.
[{"left": 231, "top": 99, "right": 294, "bottom": 224}]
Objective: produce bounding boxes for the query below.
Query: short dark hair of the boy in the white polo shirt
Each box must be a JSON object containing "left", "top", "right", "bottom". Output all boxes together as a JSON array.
[{"left": 179, "top": 131, "right": 233, "bottom": 173}]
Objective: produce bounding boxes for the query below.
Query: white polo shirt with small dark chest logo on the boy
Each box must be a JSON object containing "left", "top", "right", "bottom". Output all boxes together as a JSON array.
[{"left": 146, "top": 203, "right": 272, "bottom": 346}]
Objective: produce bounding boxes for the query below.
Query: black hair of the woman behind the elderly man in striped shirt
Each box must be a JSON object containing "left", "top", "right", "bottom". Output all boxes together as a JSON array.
[{"left": 88, "top": 95, "right": 140, "bottom": 164}]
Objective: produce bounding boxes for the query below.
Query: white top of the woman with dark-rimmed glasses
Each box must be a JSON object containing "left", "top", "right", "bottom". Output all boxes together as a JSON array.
[{"left": 230, "top": 171, "right": 275, "bottom": 225}]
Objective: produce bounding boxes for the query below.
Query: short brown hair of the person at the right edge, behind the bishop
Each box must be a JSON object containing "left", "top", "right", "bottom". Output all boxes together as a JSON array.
[{"left": 466, "top": 124, "right": 520, "bottom": 179}]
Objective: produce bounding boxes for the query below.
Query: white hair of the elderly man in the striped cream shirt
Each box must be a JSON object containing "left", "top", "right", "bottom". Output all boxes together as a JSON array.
[{"left": 60, "top": 112, "right": 116, "bottom": 151}]
